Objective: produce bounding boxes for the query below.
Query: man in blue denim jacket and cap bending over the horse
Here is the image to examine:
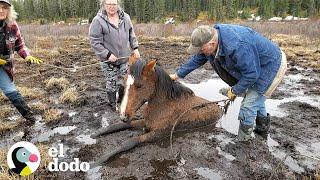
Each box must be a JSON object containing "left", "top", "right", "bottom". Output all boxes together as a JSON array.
[{"left": 170, "top": 24, "right": 287, "bottom": 141}]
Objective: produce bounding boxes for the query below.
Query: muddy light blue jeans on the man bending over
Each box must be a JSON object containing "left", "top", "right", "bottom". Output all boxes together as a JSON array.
[{"left": 238, "top": 89, "right": 267, "bottom": 125}]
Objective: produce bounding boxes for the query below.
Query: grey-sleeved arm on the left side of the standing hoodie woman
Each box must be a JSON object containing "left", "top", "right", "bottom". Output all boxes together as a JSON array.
[{"left": 89, "top": 18, "right": 111, "bottom": 60}]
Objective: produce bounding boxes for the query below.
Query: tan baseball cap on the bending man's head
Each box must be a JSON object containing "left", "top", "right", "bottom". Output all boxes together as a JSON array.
[{"left": 187, "top": 25, "right": 214, "bottom": 54}]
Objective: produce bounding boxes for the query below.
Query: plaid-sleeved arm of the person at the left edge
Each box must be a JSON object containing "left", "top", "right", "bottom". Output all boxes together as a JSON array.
[{"left": 11, "top": 22, "right": 30, "bottom": 59}]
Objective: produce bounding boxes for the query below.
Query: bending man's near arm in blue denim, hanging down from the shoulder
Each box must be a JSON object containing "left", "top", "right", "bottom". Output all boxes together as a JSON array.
[{"left": 232, "top": 43, "right": 260, "bottom": 95}]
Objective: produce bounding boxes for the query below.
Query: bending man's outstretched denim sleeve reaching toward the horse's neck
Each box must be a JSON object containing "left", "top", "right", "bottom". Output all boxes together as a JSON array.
[{"left": 176, "top": 54, "right": 208, "bottom": 78}]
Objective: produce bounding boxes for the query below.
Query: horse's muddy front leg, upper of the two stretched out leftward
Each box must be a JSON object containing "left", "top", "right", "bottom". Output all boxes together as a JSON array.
[{"left": 90, "top": 119, "right": 145, "bottom": 138}]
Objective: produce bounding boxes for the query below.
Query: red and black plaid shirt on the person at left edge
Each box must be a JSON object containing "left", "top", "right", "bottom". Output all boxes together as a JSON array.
[{"left": 5, "top": 21, "right": 30, "bottom": 59}]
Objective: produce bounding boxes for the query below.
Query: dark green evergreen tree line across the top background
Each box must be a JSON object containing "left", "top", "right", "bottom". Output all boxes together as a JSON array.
[{"left": 12, "top": 0, "right": 320, "bottom": 23}]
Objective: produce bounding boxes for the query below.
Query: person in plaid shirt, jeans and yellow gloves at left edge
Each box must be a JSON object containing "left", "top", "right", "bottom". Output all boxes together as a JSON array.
[{"left": 0, "top": 0, "right": 42, "bottom": 125}]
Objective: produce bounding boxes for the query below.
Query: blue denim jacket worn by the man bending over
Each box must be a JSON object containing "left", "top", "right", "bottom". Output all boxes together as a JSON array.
[{"left": 177, "top": 24, "right": 281, "bottom": 95}]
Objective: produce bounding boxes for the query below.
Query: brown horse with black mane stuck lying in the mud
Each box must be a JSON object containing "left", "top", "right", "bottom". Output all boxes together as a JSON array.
[{"left": 92, "top": 60, "right": 222, "bottom": 165}]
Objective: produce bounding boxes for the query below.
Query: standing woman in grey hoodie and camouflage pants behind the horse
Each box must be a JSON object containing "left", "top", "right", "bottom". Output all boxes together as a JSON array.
[{"left": 89, "top": 0, "right": 140, "bottom": 110}]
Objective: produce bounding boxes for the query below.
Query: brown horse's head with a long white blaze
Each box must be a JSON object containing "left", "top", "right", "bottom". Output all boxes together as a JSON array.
[{"left": 120, "top": 58, "right": 157, "bottom": 122}]
